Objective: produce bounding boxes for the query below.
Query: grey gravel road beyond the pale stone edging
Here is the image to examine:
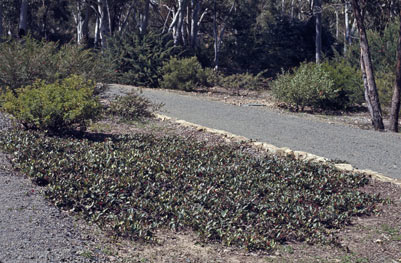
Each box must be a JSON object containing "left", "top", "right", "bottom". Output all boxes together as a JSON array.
[{"left": 143, "top": 89, "right": 401, "bottom": 179}]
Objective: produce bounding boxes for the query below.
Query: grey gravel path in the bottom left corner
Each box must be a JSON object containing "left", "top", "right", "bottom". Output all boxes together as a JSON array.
[{"left": 0, "top": 113, "right": 108, "bottom": 263}]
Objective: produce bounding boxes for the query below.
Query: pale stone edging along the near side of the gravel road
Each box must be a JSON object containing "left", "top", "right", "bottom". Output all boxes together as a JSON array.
[{"left": 155, "top": 114, "right": 401, "bottom": 186}]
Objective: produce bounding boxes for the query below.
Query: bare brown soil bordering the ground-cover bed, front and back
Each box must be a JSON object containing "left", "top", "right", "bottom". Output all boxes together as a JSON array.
[{"left": 86, "top": 117, "right": 401, "bottom": 263}]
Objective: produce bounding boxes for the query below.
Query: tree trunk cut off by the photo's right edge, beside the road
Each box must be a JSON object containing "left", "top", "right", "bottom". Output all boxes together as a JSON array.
[{"left": 389, "top": 4, "right": 401, "bottom": 132}]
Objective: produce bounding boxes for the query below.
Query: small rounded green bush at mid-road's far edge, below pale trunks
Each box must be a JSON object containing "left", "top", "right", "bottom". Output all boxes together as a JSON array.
[{"left": 160, "top": 57, "right": 207, "bottom": 91}]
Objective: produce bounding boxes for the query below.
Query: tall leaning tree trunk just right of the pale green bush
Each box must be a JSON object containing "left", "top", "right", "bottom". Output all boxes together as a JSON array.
[{"left": 352, "top": 0, "right": 384, "bottom": 130}]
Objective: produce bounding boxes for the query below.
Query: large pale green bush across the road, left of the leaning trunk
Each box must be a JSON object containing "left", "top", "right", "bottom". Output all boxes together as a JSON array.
[{"left": 273, "top": 60, "right": 364, "bottom": 110}]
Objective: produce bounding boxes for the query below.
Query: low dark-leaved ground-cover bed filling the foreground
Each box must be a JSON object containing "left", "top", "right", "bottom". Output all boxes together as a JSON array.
[{"left": 0, "top": 131, "right": 380, "bottom": 254}]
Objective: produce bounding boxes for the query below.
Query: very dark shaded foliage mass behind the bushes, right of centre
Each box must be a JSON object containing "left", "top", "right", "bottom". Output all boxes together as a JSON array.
[{"left": 217, "top": 14, "right": 335, "bottom": 77}]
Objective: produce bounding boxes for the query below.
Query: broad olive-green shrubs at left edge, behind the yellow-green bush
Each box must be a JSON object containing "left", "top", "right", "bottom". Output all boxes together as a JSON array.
[{"left": 0, "top": 36, "right": 113, "bottom": 91}]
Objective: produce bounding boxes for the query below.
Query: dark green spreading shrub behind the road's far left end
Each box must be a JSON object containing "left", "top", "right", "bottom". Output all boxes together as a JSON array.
[{"left": 105, "top": 33, "right": 178, "bottom": 87}]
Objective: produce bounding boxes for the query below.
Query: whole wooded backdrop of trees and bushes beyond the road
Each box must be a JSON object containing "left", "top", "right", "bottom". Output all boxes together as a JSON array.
[{"left": 0, "top": 0, "right": 400, "bottom": 131}]
